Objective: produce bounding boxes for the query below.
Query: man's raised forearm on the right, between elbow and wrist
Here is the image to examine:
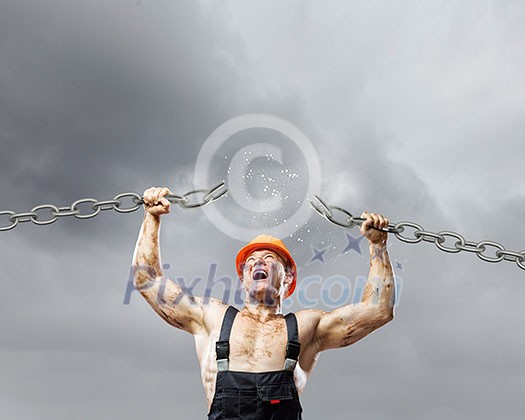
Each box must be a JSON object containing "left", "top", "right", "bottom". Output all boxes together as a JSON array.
[{"left": 362, "top": 241, "right": 395, "bottom": 317}]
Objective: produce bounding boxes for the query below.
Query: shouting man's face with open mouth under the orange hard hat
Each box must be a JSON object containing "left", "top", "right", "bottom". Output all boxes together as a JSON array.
[{"left": 243, "top": 249, "right": 287, "bottom": 302}]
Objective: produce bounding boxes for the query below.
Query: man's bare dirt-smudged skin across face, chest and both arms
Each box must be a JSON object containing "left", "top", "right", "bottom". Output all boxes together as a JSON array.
[{"left": 133, "top": 188, "right": 394, "bottom": 408}]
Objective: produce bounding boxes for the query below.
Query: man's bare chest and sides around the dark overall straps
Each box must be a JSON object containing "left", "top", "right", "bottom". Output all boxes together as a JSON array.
[{"left": 194, "top": 305, "right": 318, "bottom": 407}]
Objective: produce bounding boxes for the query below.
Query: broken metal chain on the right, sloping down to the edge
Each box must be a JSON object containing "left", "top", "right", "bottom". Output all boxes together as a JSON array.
[{"left": 310, "top": 196, "right": 525, "bottom": 270}]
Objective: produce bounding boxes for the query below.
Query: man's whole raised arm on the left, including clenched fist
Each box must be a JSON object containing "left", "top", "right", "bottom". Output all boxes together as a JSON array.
[{"left": 133, "top": 188, "right": 218, "bottom": 335}]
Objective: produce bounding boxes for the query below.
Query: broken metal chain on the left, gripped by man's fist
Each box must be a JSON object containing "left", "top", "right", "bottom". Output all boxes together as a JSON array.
[{"left": 0, "top": 181, "right": 228, "bottom": 232}]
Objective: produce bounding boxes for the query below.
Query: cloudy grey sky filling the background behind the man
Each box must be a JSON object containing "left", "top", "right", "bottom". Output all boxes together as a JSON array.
[{"left": 0, "top": 0, "right": 525, "bottom": 420}]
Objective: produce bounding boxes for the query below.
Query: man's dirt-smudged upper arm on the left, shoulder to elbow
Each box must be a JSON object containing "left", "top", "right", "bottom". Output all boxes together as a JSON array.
[{"left": 140, "top": 277, "right": 208, "bottom": 334}]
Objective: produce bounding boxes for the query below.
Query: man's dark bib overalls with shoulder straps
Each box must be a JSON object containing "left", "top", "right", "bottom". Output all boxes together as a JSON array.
[{"left": 208, "top": 306, "right": 303, "bottom": 420}]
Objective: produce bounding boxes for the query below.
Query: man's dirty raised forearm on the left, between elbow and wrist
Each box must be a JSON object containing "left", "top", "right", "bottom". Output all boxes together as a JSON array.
[{"left": 132, "top": 212, "right": 163, "bottom": 289}]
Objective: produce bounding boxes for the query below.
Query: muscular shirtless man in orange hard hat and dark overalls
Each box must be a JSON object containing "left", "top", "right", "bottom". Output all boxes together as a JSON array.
[{"left": 133, "top": 188, "right": 395, "bottom": 420}]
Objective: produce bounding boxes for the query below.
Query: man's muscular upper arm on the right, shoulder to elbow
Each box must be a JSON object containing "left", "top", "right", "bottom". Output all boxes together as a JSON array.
[{"left": 315, "top": 302, "right": 386, "bottom": 351}]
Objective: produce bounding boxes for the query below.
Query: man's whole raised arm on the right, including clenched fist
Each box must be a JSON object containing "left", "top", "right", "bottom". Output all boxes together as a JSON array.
[{"left": 313, "top": 212, "right": 395, "bottom": 351}]
